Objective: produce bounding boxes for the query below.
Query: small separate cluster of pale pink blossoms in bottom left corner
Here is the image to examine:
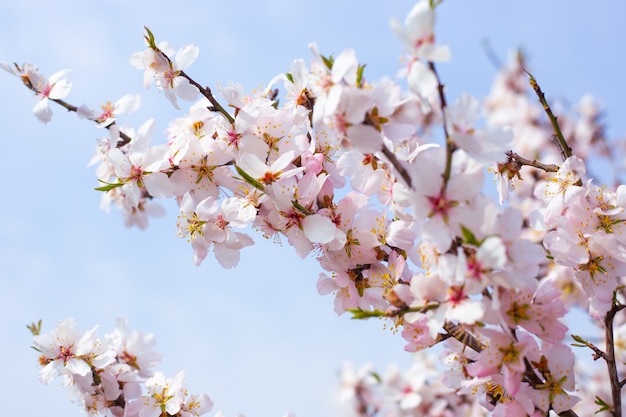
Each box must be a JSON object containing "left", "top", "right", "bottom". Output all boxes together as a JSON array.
[{"left": 32, "top": 319, "right": 213, "bottom": 417}]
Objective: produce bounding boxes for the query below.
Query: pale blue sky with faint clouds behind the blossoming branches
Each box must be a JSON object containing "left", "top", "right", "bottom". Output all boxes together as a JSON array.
[{"left": 0, "top": 0, "right": 626, "bottom": 417}]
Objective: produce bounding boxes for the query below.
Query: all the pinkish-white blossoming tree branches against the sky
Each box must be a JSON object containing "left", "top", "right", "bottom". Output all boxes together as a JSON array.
[{"left": 2, "top": 1, "right": 626, "bottom": 417}]
